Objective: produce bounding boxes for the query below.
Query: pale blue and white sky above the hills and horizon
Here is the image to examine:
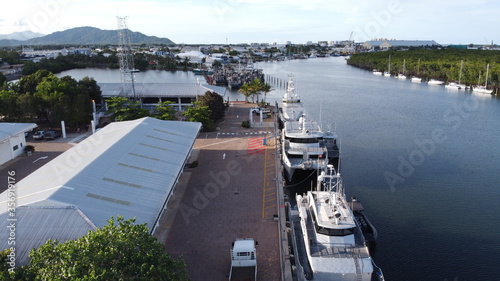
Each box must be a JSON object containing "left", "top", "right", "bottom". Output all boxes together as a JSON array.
[{"left": 0, "top": 0, "right": 500, "bottom": 44}]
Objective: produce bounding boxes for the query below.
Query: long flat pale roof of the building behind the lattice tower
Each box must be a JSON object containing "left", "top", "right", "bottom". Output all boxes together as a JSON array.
[{"left": 98, "top": 83, "right": 226, "bottom": 97}]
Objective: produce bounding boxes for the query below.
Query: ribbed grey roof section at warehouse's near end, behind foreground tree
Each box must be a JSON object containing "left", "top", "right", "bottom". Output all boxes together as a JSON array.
[{"left": 0, "top": 206, "right": 95, "bottom": 265}]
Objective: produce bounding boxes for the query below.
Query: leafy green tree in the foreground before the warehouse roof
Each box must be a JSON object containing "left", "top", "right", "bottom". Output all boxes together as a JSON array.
[{"left": 6, "top": 216, "right": 189, "bottom": 281}]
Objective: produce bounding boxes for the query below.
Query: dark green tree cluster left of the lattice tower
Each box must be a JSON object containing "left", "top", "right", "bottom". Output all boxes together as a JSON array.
[{"left": 0, "top": 70, "right": 101, "bottom": 127}]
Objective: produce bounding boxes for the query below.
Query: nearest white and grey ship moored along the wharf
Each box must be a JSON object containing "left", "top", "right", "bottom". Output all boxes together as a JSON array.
[{"left": 290, "top": 165, "right": 384, "bottom": 281}]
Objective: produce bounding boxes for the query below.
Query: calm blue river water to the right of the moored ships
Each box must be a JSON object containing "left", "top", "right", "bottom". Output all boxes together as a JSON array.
[{"left": 258, "top": 58, "right": 500, "bottom": 281}]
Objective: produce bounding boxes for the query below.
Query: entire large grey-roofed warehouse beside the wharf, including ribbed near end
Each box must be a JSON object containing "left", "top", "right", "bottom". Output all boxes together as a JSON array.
[{"left": 0, "top": 117, "right": 201, "bottom": 265}]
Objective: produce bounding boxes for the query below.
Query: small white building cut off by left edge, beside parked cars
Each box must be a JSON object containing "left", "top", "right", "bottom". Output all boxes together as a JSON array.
[{"left": 0, "top": 122, "right": 37, "bottom": 165}]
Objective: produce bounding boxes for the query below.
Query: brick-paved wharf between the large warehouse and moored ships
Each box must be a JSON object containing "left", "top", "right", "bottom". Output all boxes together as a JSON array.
[{"left": 155, "top": 103, "right": 281, "bottom": 281}]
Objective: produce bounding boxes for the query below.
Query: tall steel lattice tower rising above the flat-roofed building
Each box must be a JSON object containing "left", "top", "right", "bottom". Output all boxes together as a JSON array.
[{"left": 117, "top": 17, "right": 136, "bottom": 100}]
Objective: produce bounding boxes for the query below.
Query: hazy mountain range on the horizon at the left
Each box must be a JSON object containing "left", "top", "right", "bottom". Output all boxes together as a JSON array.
[{"left": 0, "top": 26, "right": 174, "bottom": 46}]
